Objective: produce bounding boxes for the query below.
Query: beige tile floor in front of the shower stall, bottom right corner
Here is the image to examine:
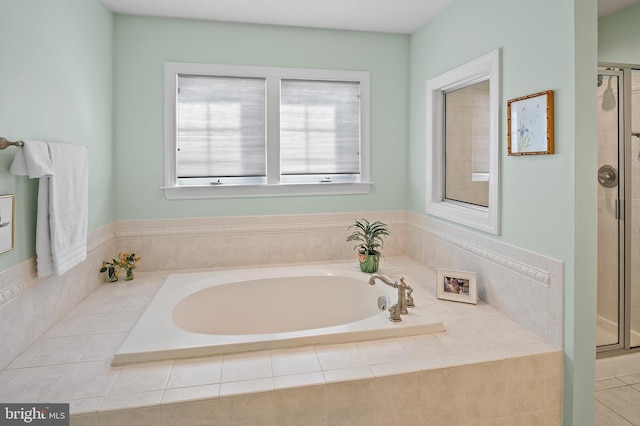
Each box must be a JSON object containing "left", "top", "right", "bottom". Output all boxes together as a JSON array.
[{"left": 596, "top": 373, "right": 640, "bottom": 426}]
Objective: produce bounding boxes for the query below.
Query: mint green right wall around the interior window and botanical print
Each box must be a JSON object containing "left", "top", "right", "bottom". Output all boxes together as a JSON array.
[{"left": 407, "top": 0, "right": 596, "bottom": 425}]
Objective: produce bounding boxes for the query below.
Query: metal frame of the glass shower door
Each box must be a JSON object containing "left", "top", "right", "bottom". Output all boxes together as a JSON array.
[{"left": 596, "top": 63, "right": 640, "bottom": 358}]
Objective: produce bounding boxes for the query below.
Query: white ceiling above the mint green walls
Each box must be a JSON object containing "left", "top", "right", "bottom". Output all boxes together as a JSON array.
[{"left": 102, "top": 0, "right": 640, "bottom": 34}]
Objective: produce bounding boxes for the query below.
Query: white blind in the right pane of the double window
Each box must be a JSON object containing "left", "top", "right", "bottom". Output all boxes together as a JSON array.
[{"left": 280, "top": 79, "right": 360, "bottom": 175}]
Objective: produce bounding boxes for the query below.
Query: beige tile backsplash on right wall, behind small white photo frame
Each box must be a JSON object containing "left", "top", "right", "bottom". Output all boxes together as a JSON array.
[{"left": 405, "top": 212, "right": 564, "bottom": 348}]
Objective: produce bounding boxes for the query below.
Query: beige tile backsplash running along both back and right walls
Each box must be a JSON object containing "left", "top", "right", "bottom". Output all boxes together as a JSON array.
[{"left": 115, "top": 210, "right": 564, "bottom": 348}]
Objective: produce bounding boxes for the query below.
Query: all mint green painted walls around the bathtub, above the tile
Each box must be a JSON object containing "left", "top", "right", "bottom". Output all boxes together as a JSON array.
[{"left": 0, "top": 0, "right": 600, "bottom": 425}]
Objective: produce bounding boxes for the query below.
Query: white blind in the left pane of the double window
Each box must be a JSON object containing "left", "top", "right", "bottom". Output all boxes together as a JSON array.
[{"left": 176, "top": 74, "right": 266, "bottom": 178}]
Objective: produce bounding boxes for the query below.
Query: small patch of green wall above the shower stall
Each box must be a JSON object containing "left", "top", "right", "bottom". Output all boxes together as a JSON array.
[{"left": 598, "top": 4, "right": 640, "bottom": 65}]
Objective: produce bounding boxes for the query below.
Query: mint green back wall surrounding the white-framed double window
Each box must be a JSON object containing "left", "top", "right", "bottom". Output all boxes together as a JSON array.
[{"left": 115, "top": 15, "right": 409, "bottom": 220}]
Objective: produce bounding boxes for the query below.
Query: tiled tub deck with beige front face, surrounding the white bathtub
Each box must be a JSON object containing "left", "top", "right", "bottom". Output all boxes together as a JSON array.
[{"left": 0, "top": 257, "right": 562, "bottom": 425}]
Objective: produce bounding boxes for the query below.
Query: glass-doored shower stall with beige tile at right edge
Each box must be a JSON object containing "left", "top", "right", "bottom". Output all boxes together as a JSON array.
[{"left": 596, "top": 65, "right": 640, "bottom": 362}]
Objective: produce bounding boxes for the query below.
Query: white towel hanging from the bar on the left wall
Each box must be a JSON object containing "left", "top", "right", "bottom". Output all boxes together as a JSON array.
[{"left": 10, "top": 141, "right": 89, "bottom": 277}]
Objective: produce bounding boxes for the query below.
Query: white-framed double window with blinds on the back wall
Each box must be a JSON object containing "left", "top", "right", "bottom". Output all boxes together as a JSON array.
[{"left": 164, "top": 63, "right": 370, "bottom": 199}]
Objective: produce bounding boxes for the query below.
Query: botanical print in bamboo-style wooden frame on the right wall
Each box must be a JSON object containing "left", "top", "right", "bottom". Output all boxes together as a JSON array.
[{"left": 507, "top": 90, "right": 553, "bottom": 155}]
